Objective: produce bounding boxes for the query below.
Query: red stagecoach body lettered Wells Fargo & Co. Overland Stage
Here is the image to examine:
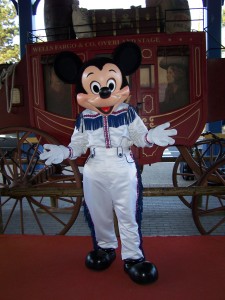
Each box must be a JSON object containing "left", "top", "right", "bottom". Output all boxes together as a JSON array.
[{"left": 1, "top": 32, "right": 207, "bottom": 164}]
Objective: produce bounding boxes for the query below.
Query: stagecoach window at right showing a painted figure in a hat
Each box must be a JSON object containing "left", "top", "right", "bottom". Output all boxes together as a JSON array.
[{"left": 157, "top": 46, "right": 190, "bottom": 113}]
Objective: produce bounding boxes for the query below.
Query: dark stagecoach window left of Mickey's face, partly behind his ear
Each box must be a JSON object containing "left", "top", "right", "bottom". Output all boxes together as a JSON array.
[{"left": 42, "top": 59, "right": 72, "bottom": 118}]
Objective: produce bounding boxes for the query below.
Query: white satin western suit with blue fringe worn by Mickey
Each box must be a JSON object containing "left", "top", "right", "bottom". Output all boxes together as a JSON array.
[{"left": 69, "top": 103, "right": 151, "bottom": 259}]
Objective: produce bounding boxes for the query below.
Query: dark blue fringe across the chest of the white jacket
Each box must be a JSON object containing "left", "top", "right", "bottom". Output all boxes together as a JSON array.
[{"left": 76, "top": 106, "right": 136, "bottom": 132}]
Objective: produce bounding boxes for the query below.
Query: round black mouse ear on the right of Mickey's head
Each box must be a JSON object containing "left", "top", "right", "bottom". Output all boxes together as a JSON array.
[{"left": 113, "top": 42, "right": 142, "bottom": 75}]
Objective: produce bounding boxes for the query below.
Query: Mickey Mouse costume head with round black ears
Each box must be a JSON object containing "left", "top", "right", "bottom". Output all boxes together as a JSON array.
[{"left": 54, "top": 42, "right": 142, "bottom": 115}]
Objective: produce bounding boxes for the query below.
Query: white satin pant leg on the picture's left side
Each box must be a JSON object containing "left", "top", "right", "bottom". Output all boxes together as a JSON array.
[{"left": 83, "top": 152, "right": 118, "bottom": 249}]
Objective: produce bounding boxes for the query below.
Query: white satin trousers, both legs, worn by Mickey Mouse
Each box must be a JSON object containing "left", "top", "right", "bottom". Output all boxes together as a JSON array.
[{"left": 84, "top": 148, "right": 143, "bottom": 259}]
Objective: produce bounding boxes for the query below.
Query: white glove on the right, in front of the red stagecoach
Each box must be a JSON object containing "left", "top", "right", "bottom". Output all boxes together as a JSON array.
[{"left": 147, "top": 122, "right": 177, "bottom": 147}]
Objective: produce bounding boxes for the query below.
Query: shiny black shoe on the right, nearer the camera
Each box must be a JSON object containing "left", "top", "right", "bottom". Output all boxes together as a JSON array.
[{"left": 124, "top": 257, "right": 158, "bottom": 284}]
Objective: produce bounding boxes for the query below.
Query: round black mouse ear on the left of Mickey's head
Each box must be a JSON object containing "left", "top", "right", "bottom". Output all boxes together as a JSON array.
[{"left": 54, "top": 52, "right": 83, "bottom": 84}]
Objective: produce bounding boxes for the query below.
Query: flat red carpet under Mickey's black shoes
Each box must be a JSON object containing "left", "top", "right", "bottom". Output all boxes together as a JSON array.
[{"left": 0, "top": 235, "right": 225, "bottom": 300}]
